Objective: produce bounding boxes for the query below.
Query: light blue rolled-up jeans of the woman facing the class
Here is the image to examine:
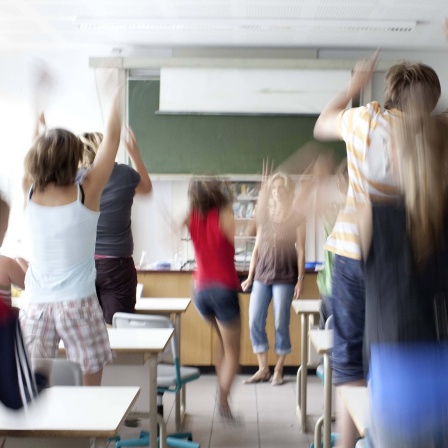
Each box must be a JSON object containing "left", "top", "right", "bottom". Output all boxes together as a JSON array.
[{"left": 249, "top": 280, "right": 295, "bottom": 355}]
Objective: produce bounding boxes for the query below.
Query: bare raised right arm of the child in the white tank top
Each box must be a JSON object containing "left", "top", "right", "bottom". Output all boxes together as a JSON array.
[{"left": 82, "top": 75, "right": 122, "bottom": 210}]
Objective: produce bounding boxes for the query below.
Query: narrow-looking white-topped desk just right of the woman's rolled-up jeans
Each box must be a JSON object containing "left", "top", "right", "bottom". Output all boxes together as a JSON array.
[{"left": 291, "top": 299, "right": 321, "bottom": 432}]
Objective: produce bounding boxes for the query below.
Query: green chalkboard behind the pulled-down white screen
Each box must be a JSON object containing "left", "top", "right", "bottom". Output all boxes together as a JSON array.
[{"left": 129, "top": 80, "right": 345, "bottom": 174}]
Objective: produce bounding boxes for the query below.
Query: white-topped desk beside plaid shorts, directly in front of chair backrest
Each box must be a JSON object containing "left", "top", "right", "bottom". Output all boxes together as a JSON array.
[{"left": 61, "top": 328, "right": 174, "bottom": 446}]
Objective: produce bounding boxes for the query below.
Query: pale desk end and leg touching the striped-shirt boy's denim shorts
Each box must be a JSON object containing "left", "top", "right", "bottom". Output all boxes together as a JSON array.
[{"left": 309, "top": 330, "right": 333, "bottom": 448}]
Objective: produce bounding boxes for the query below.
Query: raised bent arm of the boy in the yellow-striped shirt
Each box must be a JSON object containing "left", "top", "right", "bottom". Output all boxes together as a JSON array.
[{"left": 314, "top": 50, "right": 379, "bottom": 140}]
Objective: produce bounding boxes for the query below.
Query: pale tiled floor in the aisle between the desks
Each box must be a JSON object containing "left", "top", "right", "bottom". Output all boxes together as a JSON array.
[{"left": 121, "top": 374, "right": 323, "bottom": 448}]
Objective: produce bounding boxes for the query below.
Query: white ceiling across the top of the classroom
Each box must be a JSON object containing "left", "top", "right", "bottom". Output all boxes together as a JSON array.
[{"left": 0, "top": 0, "right": 448, "bottom": 51}]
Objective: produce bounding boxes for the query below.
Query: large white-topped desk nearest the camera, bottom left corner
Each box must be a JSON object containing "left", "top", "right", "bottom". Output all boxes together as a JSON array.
[{"left": 0, "top": 386, "right": 139, "bottom": 448}]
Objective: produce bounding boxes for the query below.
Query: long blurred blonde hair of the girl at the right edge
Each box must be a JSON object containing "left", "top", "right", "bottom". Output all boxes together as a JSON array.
[{"left": 394, "top": 89, "right": 448, "bottom": 262}]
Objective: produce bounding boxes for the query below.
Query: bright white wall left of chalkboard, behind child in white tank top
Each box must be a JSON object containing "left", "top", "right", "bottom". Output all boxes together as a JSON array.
[{"left": 0, "top": 50, "right": 103, "bottom": 255}]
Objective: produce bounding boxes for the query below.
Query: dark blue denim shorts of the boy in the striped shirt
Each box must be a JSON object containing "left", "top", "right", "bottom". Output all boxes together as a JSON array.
[{"left": 331, "top": 255, "right": 366, "bottom": 385}]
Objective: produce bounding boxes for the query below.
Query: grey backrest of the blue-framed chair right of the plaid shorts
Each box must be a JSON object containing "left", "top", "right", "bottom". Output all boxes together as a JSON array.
[{"left": 112, "top": 312, "right": 178, "bottom": 363}]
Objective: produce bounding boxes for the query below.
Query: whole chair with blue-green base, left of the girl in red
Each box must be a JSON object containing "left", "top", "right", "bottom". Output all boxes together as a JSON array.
[{"left": 112, "top": 313, "right": 201, "bottom": 448}]
